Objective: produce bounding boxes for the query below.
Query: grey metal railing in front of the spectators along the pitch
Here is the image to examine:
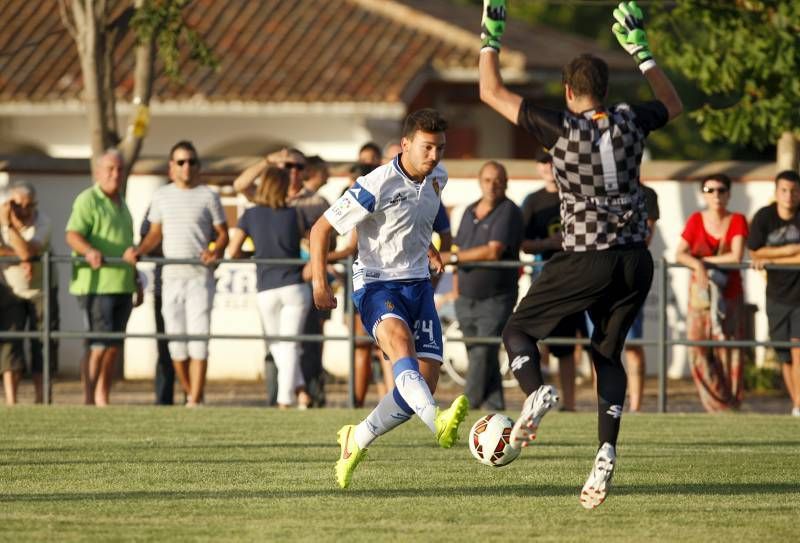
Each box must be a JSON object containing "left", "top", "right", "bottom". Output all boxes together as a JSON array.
[{"left": 0, "top": 252, "right": 800, "bottom": 413}]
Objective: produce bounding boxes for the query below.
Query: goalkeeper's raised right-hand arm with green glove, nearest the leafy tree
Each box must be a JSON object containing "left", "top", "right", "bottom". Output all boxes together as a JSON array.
[{"left": 611, "top": 2, "right": 683, "bottom": 120}]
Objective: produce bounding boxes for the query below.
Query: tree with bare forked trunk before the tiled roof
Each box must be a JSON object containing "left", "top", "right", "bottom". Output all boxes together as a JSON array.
[{"left": 58, "top": 0, "right": 217, "bottom": 191}]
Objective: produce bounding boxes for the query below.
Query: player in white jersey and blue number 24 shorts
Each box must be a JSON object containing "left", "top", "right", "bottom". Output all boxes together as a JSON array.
[{"left": 311, "top": 109, "right": 469, "bottom": 488}]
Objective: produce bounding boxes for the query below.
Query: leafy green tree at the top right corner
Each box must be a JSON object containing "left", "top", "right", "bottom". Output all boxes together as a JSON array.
[{"left": 650, "top": 0, "right": 800, "bottom": 168}]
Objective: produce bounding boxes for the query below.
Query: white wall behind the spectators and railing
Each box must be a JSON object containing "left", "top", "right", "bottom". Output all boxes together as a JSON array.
[{"left": 0, "top": 173, "right": 773, "bottom": 379}]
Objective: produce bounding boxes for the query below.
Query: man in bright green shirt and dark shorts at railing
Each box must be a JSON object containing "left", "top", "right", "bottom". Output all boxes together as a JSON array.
[{"left": 66, "top": 149, "right": 141, "bottom": 406}]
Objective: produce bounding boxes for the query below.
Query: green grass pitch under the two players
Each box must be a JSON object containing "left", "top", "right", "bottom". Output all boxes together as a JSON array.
[{"left": 0, "top": 406, "right": 800, "bottom": 542}]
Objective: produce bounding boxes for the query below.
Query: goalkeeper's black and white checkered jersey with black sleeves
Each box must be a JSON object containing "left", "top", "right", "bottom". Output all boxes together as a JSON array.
[{"left": 518, "top": 100, "right": 669, "bottom": 251}]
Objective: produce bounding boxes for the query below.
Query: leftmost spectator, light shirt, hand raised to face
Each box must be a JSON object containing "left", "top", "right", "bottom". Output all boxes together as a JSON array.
[{"left": 0, "top": 181, "right": 59, "bottom": 403}]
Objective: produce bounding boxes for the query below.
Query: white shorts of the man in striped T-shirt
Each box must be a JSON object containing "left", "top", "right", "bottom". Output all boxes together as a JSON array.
[{"left": 161, "top": 273, "right": 215, "bottom": 360}]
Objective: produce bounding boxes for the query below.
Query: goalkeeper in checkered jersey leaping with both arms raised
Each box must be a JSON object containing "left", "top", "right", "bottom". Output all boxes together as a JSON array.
[{"left": 479, "top": 0, "right": 683, "bottom": 509}]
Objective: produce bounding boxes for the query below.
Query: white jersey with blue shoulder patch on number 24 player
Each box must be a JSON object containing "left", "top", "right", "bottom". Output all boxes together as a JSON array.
[{"left": 325, "top": 155, "right": 447, "bottom": 290}]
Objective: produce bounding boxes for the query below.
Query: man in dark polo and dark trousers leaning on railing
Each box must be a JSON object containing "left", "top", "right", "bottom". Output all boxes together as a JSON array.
[{"left": 442, "top": 160, "right": 523, "bottom": 411}]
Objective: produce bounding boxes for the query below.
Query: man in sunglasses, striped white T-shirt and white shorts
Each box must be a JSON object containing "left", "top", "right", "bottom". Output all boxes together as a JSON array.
[{"left": 127, "top": 141, "right": 228, "bottom": 407}]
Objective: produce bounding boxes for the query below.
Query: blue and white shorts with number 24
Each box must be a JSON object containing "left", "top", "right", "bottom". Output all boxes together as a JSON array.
[{"left": 353, "top": 279, "right": 442, "bottom": 362}]
